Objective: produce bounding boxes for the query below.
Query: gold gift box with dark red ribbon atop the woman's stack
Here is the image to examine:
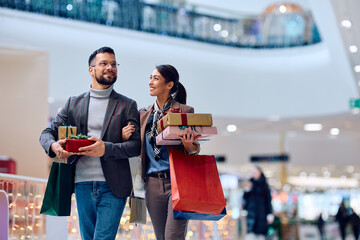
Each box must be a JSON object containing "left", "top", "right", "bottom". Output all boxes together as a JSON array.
[{"left": 157, "top": 113, "right": 213, "bottom": 133}]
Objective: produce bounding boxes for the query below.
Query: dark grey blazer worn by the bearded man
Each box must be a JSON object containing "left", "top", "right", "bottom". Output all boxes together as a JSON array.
[{"left": 40, "top": 90, "right": 140, "bottom": 198}]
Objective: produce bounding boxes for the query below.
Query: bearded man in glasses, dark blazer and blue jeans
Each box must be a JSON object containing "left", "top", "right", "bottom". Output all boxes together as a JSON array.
[{"left": 40, "top": 47, "right": 140, "bottom": 240}]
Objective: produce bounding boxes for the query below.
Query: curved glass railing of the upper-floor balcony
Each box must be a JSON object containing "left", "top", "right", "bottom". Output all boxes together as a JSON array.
[{"left": 0, "top": 0, "right": 321, "bottom": 48}]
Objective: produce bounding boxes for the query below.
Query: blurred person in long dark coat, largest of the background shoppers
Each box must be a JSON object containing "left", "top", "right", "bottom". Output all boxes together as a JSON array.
[{"left": 243, "top": 166, "right": 273, "bottom": 240}]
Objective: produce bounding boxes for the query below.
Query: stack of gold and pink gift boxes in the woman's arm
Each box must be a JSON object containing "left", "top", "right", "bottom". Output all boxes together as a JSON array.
[{"left": 156, "top": 113, "right": 217, "bottom": 145}]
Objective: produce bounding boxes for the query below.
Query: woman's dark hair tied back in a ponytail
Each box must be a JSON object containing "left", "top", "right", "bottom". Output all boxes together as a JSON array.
[{"left": 156, "top": 64, "right": 186, "bottom": 104}]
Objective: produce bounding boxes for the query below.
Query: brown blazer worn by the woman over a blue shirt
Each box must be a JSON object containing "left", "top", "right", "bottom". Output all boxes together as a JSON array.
[{"left": 140, "top": 100, "right": 194, "bottom": 180}]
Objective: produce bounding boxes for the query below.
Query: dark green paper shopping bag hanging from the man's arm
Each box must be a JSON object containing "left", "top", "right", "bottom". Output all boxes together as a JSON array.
[{"left": 40, "top": 162, "right": 74, "bottom": 216}]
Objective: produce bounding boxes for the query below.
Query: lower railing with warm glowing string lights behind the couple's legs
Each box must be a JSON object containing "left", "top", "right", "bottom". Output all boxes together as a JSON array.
[{"left": 0, "top": 173, "right": 238, "bottom": 240}]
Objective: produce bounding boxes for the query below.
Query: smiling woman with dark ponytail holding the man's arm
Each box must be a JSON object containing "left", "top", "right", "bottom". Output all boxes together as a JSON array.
[{"left": 123, "top": 65, "right": 199, "bottom": 240}]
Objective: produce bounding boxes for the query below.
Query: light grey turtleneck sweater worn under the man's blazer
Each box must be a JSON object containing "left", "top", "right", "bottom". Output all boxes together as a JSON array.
[{"left": 75, "top": 86, "right": 113, "bottom": 183}]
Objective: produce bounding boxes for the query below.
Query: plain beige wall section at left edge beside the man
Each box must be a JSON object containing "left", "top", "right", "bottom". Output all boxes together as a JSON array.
[{"left": 0, "top": 47, "right": 48, "bottom": 177}]
